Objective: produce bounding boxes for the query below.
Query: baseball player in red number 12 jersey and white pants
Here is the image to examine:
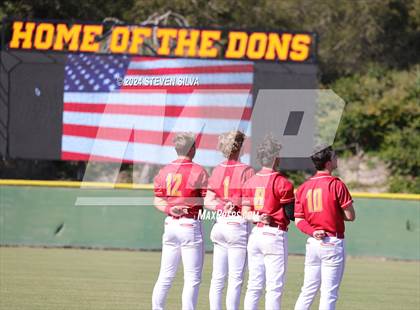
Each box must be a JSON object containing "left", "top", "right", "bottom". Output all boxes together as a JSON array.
[{"left": 152, "top": 133, "right": 208, "bottom": 310}]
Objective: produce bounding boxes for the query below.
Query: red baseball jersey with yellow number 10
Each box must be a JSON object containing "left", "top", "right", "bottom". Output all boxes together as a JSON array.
[{"left": 295, "top": 172, "right": 353, "bottom": 234}]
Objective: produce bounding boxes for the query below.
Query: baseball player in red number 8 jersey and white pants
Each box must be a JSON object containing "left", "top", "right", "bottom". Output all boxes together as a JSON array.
[{"left": 243, "top": 137, "right": 294, "bottom": 310}]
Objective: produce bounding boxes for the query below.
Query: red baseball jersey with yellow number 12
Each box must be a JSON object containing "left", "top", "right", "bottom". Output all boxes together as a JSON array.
[{"left": 154, "top": 159, "right": 208, "bottom": 214}]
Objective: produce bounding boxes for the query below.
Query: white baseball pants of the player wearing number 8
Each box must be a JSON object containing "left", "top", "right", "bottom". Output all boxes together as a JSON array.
[{"left": 244, "top": 226, "right": 288, "bottom": 310}]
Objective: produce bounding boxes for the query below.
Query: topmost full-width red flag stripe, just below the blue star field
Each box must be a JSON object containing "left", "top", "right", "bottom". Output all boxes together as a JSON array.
[{"left": 64, "top": 102, "right": 252, "bottom": 120}]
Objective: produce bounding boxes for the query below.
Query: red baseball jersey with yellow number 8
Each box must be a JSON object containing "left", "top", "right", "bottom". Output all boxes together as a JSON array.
[{"left": 243, "top": 168, "right": 294, "bottom": 230}]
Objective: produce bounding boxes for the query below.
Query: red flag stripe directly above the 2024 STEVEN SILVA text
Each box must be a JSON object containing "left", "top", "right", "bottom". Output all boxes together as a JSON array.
[{"left": 126, "top": 65, "right": 254, "bottom": 75}]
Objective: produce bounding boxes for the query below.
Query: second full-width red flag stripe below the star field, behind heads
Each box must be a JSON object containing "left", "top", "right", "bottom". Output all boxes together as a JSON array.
[{"left": 63, "top": 124, "right": 250, "bottom": 153}]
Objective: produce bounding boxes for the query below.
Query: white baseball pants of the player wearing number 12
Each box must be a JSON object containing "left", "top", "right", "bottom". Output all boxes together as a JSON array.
[{"left": 152, "top": 216, "right": 204, "bottom": 310}]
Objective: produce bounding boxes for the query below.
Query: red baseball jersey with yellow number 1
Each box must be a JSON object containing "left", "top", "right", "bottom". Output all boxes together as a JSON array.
[{"left": 208, "top": 160, "right": 255, "bottom": 211}]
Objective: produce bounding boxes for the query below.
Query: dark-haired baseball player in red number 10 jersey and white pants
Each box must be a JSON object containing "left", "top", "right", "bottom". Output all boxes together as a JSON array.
[{"left": 295, "top": 147, "right": 355, "bottom": 310}]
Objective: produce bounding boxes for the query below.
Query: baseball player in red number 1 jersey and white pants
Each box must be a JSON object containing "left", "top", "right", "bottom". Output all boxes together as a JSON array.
[{"left": 205, "top": 130, "right": 254, "bottom": 310}]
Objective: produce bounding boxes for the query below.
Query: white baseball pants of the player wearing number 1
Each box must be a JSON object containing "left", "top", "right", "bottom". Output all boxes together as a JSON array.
[{"left": 209, "top": 216, "right": 249, "bottom": 310}]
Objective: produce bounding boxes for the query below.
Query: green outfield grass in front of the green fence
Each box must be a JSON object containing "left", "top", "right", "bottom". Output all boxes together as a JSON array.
[{"left": 0, "top": 248, "right": 420, "bottom": 310}]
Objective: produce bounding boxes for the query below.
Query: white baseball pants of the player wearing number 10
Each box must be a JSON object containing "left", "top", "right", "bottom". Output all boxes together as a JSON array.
[{"left": 295, "top": 237, "right": 345, "bottom": 310}]
